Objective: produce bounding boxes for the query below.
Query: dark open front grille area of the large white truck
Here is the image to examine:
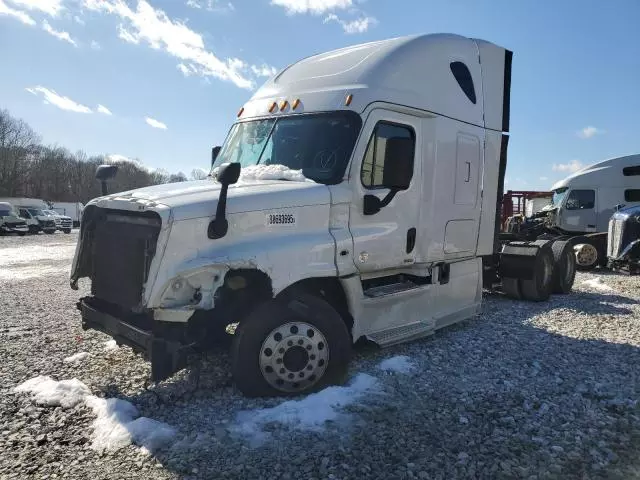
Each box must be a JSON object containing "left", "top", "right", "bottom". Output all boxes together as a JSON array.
[{"left": 91, "top": 211, "right": 161, "bottom": 310}]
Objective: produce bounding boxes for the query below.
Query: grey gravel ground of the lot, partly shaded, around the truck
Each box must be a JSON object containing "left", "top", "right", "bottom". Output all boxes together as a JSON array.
[{"left": 0, "top": 231, "right": 640, "bottom": 480}]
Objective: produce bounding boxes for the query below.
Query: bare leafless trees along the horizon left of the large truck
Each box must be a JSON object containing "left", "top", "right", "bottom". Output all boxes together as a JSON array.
[{"left": 0, "top": 110, "right": 206, "bottom": 203}]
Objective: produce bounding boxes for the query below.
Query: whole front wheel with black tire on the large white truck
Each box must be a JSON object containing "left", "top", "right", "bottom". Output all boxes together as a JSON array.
[{"left": 231, "top": 294, "right": 351, "bottom": 397}]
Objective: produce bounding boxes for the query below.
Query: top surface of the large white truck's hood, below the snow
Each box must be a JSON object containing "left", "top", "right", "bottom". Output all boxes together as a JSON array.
[{"left": 99, "top": 179, "right": 330, "bottom": 220}]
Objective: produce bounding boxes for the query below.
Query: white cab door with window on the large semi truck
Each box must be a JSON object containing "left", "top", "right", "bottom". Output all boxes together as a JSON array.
[{"left": 349, "top": 109, "right": 421, "bottom": 276}]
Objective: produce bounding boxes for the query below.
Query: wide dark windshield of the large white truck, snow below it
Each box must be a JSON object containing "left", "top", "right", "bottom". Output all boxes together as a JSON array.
[{"left": 213, "top": 111, "right": 362, "bottom": 185}]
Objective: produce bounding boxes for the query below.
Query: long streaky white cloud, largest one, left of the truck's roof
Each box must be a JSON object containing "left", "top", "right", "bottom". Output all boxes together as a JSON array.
[{"left": 84, "top": 0, "right": 254, "bottom": 89}]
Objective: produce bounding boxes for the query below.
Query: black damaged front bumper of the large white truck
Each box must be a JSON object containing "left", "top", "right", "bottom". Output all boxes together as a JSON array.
[{"left": 77, "top": 297, "right": 195, "bottom": 382}]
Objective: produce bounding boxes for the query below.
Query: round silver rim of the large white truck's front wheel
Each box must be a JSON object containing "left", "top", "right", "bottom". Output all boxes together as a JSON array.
[{"left": 260, "top": 322, "right": 329, "bottom": 392}]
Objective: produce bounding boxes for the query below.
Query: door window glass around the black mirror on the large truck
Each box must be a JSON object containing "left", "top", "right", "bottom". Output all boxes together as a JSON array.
[{"left": 360, "top": 122, "right": 416, "bottom": 188}]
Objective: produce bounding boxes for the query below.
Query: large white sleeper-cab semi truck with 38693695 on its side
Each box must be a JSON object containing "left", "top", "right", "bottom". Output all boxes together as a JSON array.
[{"left": 70, "top": 34, "right": 575, "bottom": 396}]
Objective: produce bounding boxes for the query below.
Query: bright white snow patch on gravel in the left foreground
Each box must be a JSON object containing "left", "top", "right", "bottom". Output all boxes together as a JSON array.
[{"left": 14, "top": 376, "right": 176, "bottom": 452}]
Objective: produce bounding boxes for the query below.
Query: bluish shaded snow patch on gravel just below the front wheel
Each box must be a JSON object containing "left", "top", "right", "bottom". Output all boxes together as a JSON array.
[{"left": 229, "top": 373, "right": 378, "bottom": 446}]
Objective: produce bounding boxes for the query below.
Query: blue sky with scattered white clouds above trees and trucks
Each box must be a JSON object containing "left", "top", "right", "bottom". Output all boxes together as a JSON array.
[{"left": 0, "top": 0, "right": 640, "bottom": 189}]
